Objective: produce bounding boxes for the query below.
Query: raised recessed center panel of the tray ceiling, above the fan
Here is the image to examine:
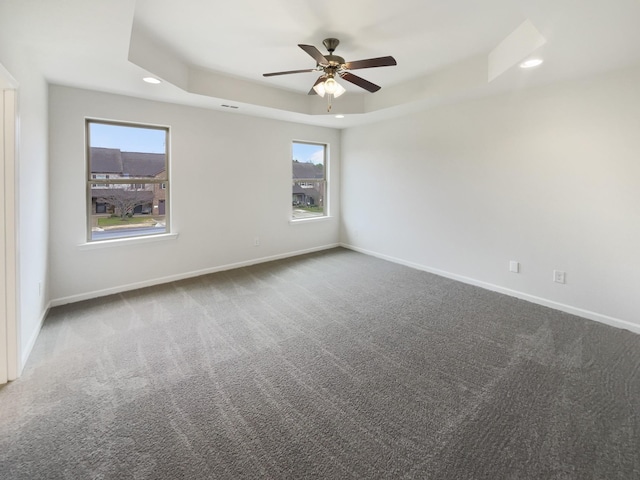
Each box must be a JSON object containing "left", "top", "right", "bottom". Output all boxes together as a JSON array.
[{"left": 135, "top": 0, "right": 526, "bottom": 93}]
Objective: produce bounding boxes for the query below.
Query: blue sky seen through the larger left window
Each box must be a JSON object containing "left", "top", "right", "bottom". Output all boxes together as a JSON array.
[{"left": 89, "top": 123, "right": 166, "bottom": 153}]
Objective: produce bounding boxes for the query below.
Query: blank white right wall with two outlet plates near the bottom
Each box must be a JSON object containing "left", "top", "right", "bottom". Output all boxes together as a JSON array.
[{"left": 341, "top": 63, "right": 640, "bottom": 332}]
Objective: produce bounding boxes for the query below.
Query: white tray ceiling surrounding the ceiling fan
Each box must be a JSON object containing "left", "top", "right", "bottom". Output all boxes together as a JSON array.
[{"left": 0, "top": 0, "right": 640, "bottom": 128}]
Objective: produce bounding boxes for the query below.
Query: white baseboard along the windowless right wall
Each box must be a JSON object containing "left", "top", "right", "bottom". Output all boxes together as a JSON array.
[{"left": 340, "top": 243, "right": 640, "bottom": 334}]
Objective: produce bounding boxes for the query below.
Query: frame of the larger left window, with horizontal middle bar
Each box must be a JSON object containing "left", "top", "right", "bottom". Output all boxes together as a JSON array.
[{"left": 85, "top": 117, "right": 172, "bottom": 245}]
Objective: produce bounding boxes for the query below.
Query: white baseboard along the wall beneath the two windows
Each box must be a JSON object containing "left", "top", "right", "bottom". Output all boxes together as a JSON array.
[{"left": 50, "top": 243, "right": 340, "bottom": 308}]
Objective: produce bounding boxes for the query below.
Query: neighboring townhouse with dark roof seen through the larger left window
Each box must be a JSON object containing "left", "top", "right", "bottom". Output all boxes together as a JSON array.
[{"left": 90, "top": 147, "right": 166, "bottom": 215}]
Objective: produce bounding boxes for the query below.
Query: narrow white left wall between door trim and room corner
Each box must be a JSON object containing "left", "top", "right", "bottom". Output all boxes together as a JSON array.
[{"left": 0, "top": 59, "right": 49, "bottom": 374}]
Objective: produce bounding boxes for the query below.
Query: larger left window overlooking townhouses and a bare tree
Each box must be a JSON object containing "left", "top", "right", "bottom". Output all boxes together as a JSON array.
[{"left": 86, "top": 120, "right": 169, "bottom": 241}]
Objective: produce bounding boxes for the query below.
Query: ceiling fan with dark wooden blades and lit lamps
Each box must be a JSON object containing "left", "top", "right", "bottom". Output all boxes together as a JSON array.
[{"left": 263, "top": 38, "right": 397, "bottom": 104}]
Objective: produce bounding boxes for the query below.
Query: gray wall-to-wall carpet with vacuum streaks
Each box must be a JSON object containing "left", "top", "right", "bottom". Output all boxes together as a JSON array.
[{"left": 0, "top": 249, "right": 640, "bottom": 480}]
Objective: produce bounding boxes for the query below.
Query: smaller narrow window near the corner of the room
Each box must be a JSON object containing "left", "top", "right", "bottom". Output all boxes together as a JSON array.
[{"left": 291, "top": 142, "right": 327, "bottom": 220}]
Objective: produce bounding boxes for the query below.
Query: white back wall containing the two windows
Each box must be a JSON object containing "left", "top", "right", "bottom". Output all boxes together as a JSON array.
[{"left": 49, "top": 85, "right": 340, "bottom": 304}]
